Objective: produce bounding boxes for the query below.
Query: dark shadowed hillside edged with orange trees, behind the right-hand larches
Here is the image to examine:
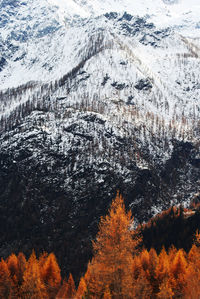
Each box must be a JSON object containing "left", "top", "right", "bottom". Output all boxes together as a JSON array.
[{"left": 141, "top": 199, "right": 200, "bottom": 252}]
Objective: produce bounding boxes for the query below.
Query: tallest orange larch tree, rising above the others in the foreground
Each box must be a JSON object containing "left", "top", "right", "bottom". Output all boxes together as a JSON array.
[{"left": 87, "top": 194, "right": 141, "bottom": 299}]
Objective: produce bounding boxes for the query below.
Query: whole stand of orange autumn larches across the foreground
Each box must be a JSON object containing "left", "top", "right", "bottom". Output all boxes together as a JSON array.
[{"left": 0, "top": 194, "right": 200, "bottom": 299}]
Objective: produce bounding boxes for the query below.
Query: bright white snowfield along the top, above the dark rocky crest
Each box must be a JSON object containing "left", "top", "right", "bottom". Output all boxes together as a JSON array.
[{"left": 48, "top": 0, "right": 200, "bottom": 25}]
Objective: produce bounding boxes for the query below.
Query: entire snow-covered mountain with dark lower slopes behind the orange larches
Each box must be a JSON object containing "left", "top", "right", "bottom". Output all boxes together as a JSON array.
[{"left": 0, "top": 0, "right": 200, "bottom": 273}]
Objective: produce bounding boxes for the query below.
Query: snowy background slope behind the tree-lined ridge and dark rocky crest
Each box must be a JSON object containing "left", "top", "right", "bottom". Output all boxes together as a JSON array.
[{"left": 0, "top": 0, "right": 200, "bottom": 89}]
